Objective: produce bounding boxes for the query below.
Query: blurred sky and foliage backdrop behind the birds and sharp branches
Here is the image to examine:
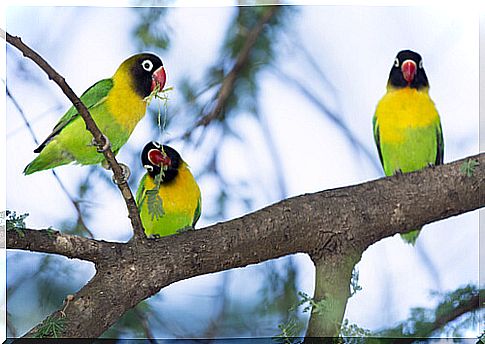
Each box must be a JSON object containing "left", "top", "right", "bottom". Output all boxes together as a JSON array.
[{"left": 3, "top": 2, "right": 483, "bottom": 338}]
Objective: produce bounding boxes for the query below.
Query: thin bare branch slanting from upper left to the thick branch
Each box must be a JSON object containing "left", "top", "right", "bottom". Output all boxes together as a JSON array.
[{"left": 6, "top": 32, "right": 145, "bottom": 240}]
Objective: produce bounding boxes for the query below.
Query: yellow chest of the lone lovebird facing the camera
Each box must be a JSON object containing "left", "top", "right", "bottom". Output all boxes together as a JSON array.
[{"left": 375, "top": 88, "right": 439, "bottom": 141}]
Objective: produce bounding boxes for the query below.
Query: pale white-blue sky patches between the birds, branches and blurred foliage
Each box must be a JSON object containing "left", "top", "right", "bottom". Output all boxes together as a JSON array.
[{"left": 0, "top": 2, "right": 479, "bottom": 335}]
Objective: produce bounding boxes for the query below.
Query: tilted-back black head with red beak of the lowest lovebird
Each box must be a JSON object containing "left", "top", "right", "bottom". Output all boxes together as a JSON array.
[{"left": 141, "top": 141, "right": 182, "bottom": 183}]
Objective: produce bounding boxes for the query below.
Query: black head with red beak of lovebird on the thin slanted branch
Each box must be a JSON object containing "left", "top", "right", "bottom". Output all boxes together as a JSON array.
[{"left": 122, "top": 53, "right": 167, "bottom": 98}]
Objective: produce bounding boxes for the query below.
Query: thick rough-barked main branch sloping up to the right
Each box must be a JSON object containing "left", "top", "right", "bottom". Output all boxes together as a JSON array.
[{"left": 7, "top": 154, "right": 485, "bottom": 337}]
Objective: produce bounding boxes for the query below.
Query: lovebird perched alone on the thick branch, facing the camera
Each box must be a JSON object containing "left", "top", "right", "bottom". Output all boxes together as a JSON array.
[{"left": 373, "top": 50, "right": 444, "bottom": 245}]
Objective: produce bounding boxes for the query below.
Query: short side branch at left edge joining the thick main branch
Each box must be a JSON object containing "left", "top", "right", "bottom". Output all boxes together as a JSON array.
[{"left": 7, "top": 228, "right": 123, "bottom": 263}]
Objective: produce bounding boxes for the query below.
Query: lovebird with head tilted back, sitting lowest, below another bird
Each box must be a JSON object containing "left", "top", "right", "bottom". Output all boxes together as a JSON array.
[{"left": 136, "top": 141, "right": 201, "bottom": 238}]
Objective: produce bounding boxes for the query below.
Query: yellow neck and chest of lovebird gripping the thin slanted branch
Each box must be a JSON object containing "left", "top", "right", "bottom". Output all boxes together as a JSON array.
[{"left": 106, "top": 70, "right": 147, "bottom": 134}]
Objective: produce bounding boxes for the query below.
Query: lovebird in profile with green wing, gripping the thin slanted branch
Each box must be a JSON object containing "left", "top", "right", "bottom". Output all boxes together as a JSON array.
[{"left": 24, "top": 53, "right": 166, "bottom": 175}]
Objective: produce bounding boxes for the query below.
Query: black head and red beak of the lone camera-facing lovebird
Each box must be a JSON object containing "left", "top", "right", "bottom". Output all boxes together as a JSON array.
[{"left": 389, "top": 50, "right": 429, "bottom": 90}]
